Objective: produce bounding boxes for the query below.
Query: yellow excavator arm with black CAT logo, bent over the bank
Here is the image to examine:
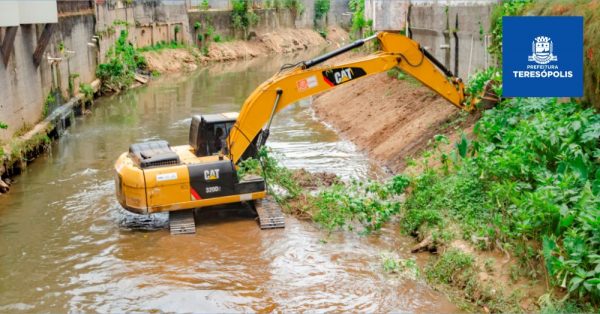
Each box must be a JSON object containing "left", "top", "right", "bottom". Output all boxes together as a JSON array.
[{"left": 227, "top": 32, "right": 473, "bottom": 164}]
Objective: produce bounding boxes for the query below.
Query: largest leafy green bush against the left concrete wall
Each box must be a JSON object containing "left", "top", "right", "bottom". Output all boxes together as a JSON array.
[{"left": 96, "top": 30, "right": 147, "bottom": 92}]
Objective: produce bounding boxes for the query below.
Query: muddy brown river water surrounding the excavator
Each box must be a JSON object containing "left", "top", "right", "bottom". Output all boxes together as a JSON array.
[{"left": 0, "top": 53, "right": 456, "bottom": 313}]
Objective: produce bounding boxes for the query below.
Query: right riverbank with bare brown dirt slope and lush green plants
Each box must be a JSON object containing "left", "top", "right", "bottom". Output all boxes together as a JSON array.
[{"left": 301, "top": 73, "right": 600, "bottom": 312}]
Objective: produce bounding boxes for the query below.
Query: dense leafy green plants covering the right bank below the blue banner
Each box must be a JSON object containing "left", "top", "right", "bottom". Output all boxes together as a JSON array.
[{"left": 402, "top": 98, "right": 600, "bottom": 304}]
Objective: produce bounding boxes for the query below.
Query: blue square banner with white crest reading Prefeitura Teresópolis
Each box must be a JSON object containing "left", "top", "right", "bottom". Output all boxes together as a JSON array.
[{"left": 502, "top": 16, "right": 583, "bottom": 97}]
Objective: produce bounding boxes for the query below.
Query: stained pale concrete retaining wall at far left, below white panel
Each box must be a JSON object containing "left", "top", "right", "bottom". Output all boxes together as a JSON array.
[{"left": 0, "top": 11, "right": 96, "bottom": 140}]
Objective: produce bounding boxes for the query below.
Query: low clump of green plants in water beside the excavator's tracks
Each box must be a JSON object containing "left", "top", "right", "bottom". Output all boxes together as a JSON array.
[{"left": 238, "top": 149, "right": 409, "bottom": 233}]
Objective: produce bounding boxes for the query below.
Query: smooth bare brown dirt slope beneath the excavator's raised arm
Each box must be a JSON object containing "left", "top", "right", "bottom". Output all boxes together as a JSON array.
[{"left": 313, "top": 73, "right": 459, "bottom": 171}]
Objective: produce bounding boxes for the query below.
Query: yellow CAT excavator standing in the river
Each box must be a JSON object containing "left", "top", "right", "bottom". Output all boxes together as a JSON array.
[{"left": 115, "top": 32, "right": 488, "bottom": 234}]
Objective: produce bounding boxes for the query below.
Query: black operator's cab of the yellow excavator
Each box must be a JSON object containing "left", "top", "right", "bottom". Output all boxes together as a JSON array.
[{"left": 189, "top": 112, "right": 238, "bottom": 157}]
